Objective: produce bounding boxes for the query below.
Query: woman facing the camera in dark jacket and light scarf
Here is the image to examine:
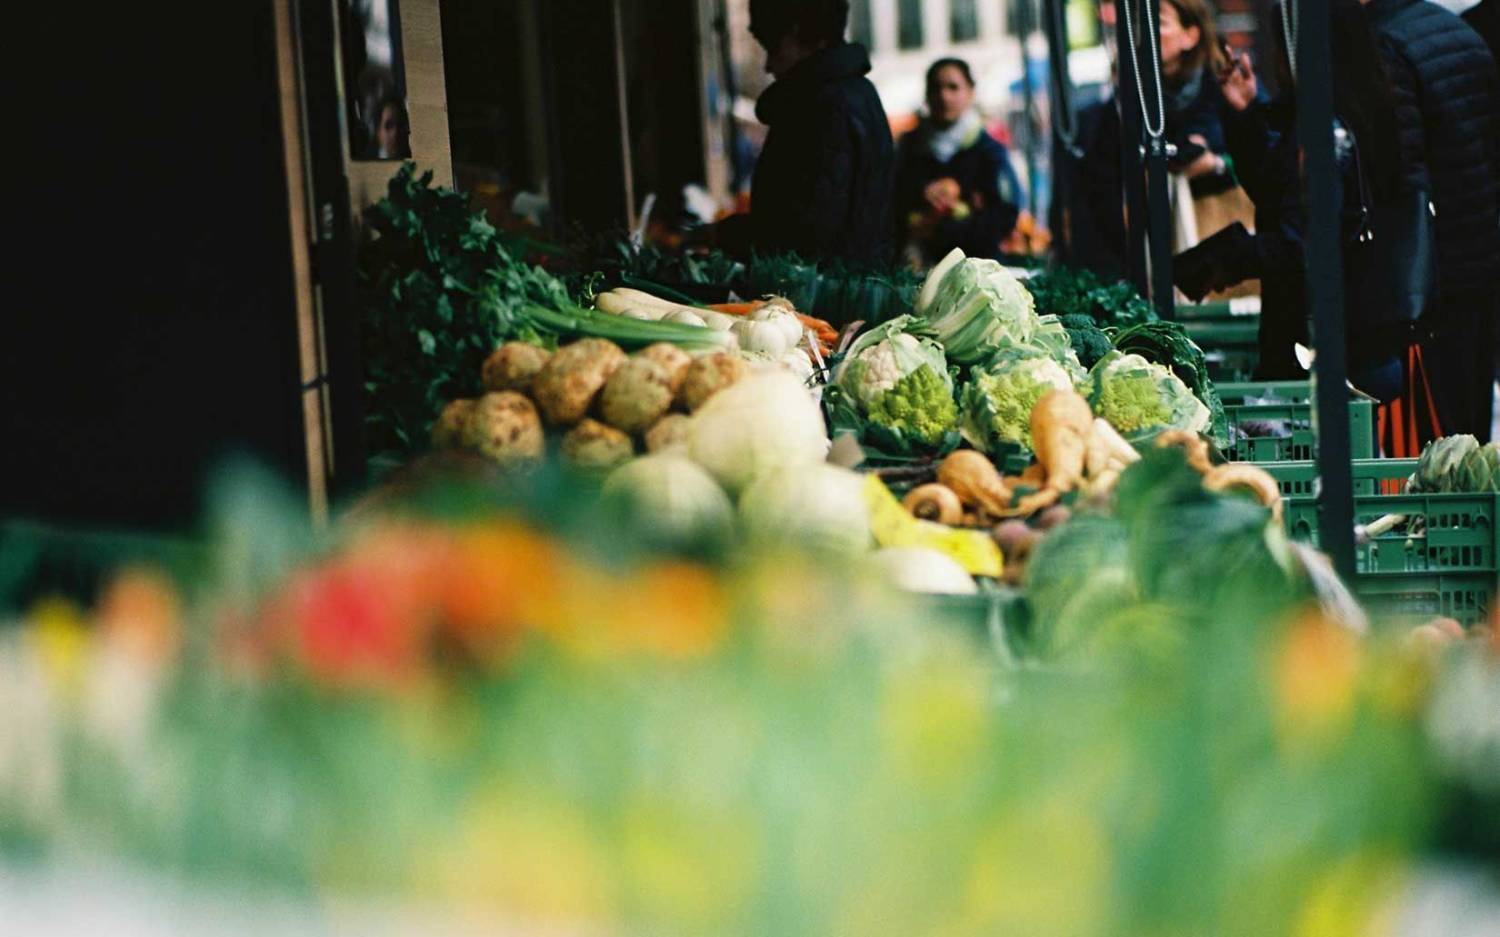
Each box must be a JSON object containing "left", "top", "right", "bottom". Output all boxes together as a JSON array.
[{"left": 896, "top": 58, "right": 1020, "bottom": 265}]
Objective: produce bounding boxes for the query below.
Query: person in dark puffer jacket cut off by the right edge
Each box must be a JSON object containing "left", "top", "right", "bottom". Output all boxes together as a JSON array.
[{"left": 1365, "top": 0, "right": 1500, "bottom": 439}]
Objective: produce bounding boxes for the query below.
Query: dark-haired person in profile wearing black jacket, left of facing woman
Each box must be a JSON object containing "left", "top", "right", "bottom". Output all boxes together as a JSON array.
[{"left": 711, "top": 0, "right": 894, "bottom": 267}]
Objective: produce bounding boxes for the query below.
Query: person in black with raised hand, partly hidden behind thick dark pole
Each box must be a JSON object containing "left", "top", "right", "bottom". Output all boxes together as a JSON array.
[{"left": 1173, "top": 0, "right": 1407, "bottom": 402}]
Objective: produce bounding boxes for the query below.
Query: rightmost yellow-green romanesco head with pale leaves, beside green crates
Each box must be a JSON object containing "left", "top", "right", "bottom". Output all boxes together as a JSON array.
[{"left": 1089, "top": 351, "right": 1211, "bottom": 436}]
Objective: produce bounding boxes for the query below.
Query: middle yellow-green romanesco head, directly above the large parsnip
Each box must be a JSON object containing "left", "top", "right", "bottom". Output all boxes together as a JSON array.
[{"left": 959, "top": 354, "right": 1073, "bottom": 451}]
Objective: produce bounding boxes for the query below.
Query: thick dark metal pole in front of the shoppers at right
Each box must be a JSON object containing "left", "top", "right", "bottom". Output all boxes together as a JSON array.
[{"left": 1284, "top": 0, "right": 1355, "bottom": 580}]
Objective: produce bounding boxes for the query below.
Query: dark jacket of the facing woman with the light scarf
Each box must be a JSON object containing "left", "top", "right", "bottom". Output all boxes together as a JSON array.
[{"left": 896, "top": 123, "right": 1020, "bottom": 262}]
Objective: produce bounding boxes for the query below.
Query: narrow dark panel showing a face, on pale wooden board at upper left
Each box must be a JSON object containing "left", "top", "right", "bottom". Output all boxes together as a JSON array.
[{"left": 339, "top": 0, "right": 411, "bottom": 160}]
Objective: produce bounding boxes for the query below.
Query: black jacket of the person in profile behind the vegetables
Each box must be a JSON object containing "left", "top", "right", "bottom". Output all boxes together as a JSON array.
[{"left": 720, "top": 43, "right": 896, "bottom": 264}]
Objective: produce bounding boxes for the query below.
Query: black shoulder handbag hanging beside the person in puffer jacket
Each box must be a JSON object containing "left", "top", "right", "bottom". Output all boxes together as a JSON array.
[{"left": 1344, "top": 124, "right": 1437, "bottom": 361}]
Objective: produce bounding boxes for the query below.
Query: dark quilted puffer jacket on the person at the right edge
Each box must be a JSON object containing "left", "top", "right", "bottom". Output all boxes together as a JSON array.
[{"left": 1367, "top": 0, "right": 1500, "bottom": 300}]
